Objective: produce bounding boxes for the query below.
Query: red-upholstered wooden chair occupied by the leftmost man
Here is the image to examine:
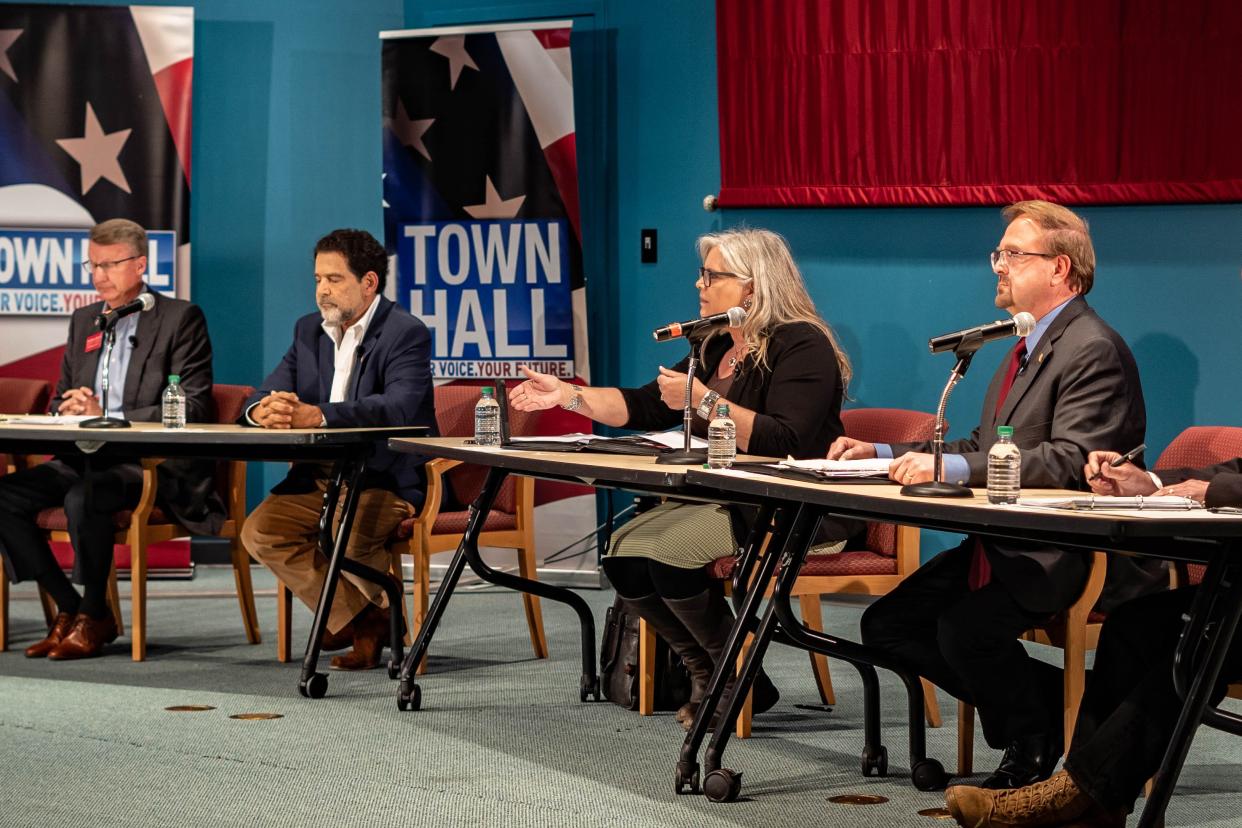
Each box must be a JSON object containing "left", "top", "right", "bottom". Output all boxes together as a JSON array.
[{"left": 26, "top": 385, "right": 262, "bottom": 662}]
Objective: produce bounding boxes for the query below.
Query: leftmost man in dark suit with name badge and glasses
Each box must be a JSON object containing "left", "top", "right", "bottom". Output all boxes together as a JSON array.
[{"left": 0, "top": 218, "right": 224, "bottom": 660}]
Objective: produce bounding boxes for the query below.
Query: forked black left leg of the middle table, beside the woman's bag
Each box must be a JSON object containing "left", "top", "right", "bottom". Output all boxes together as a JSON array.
[{"left": 397, "top": 468, "right": 600, "bottom": 710}]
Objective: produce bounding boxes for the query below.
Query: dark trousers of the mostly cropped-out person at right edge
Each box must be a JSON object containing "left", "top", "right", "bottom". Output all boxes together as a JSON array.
[{"left": 1066, "top": 587, "right": 1242, "bottom": 812}]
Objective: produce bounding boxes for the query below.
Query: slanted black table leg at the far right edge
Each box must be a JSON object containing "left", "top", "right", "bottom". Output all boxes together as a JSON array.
[{"left": 1139, "top": 555, "right": 1242, "bottom": 828}]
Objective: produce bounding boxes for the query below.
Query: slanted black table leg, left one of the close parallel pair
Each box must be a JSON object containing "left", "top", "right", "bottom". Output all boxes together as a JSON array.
[{"left": 673, "top": 505, "right": 794, "bottom": 793}]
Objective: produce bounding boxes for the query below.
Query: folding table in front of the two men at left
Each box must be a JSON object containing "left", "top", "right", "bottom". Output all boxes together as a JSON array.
[{"left": 0, "top": 417, "right": 427, "bottom": 699}]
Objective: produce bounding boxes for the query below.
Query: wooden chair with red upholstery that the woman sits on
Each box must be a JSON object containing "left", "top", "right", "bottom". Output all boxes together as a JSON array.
[{"left": 638, "top": 408, "right": 940, "bottom": 739}]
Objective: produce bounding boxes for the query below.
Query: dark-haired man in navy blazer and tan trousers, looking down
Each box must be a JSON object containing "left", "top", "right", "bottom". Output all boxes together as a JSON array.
[{"left": 242, "top": 230, "right": 436, "bottom": 670}]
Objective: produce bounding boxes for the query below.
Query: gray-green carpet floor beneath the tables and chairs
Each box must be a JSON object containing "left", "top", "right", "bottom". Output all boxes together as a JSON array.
[{"left": 0, "top": 567, "right": 1242, "bottom": 827}]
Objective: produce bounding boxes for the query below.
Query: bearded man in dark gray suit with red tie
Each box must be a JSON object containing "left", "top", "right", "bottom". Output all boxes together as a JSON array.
[{"left": 830, "top": 201, "right": 1163, "bottom": 788}]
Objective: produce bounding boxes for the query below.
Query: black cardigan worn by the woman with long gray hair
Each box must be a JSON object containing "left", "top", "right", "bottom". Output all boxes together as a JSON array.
[{"left": 621, "top": 322, "right": 845, "bottom": 459}]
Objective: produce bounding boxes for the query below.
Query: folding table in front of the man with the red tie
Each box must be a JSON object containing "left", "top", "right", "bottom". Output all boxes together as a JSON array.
[{"left": 678, "top": 469, "right": 1242, "bottom": 828}]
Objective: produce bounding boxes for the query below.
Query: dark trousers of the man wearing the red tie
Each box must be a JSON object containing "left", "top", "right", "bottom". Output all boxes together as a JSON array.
[{"left": 862, "top": 538, "right": 1063, "bottom": 749}]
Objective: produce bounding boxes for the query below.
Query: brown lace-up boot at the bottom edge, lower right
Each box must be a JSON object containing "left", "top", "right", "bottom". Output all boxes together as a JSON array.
[{"left": 944, "top": 771, "right": 1092, "bottom": 828}]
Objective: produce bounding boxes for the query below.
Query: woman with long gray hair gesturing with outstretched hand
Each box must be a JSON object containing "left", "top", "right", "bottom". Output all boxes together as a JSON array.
[{"left": 509, "top": 230, "right": 851, "bottom": 729}]
